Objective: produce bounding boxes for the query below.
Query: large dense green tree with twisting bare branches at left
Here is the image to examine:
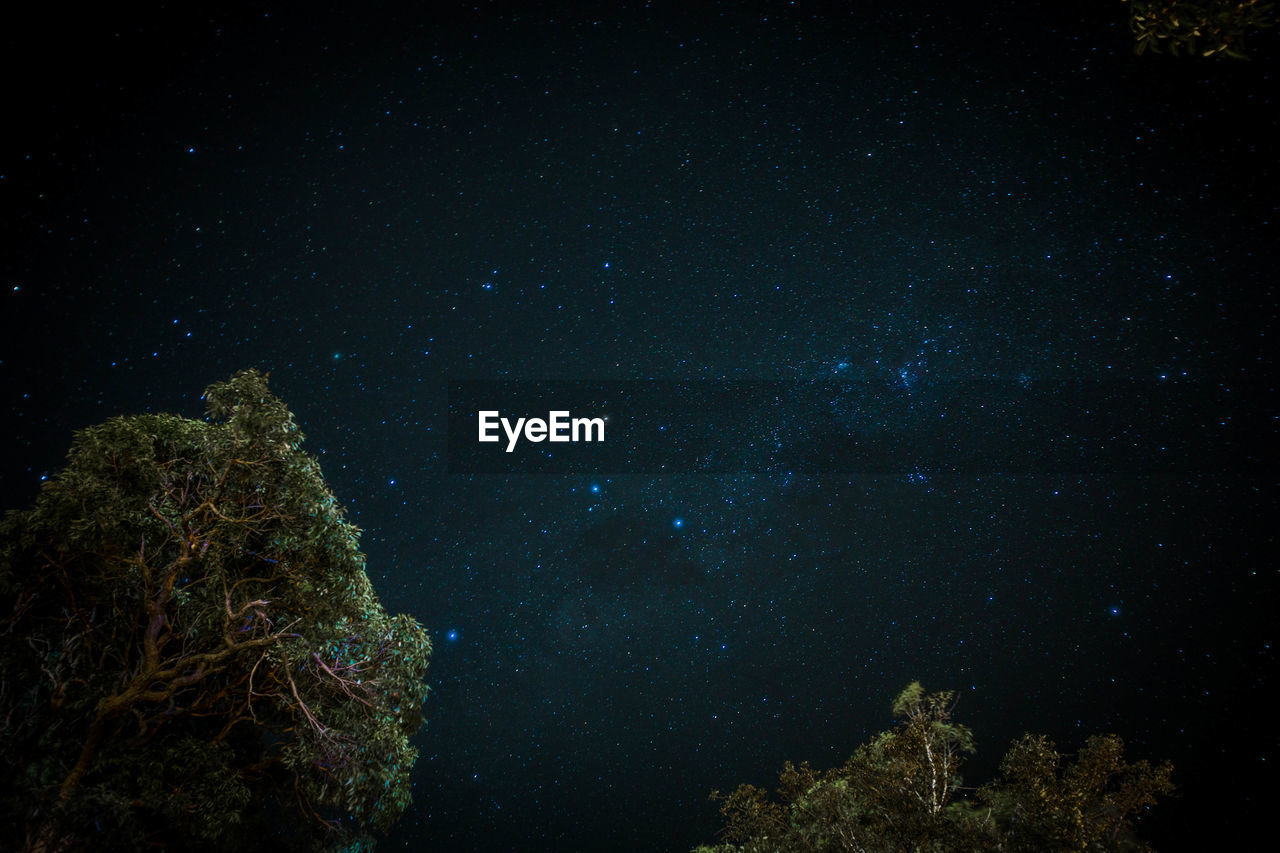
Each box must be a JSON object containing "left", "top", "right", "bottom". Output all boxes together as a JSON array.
[{"left": 0, "top": 370, "right": 431, "bottom": 850}]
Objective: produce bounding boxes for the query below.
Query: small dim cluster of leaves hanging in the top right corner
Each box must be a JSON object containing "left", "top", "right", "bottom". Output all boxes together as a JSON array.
[{"left": 1128, "top": 0, "right": 1276, "bottom": 59}]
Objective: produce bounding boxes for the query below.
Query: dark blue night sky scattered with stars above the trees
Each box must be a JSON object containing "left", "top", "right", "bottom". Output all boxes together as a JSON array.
[{"left": 0, "top": 0, "right": 1280, "bottom": 850}]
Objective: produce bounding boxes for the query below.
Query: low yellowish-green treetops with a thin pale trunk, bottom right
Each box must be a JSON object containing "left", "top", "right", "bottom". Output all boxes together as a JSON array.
[{"left": 695, "top": 683, "right": 1172, "bottom": 853}]
